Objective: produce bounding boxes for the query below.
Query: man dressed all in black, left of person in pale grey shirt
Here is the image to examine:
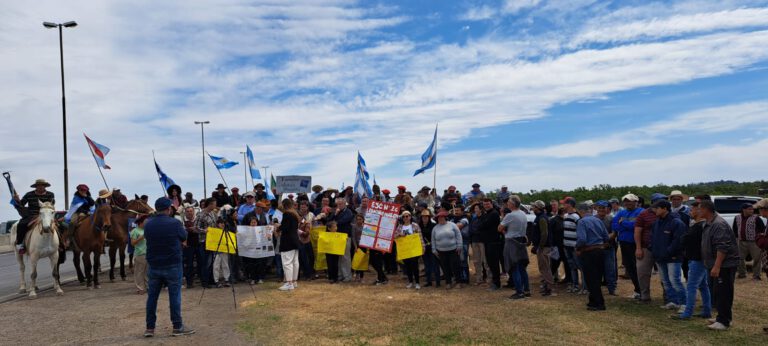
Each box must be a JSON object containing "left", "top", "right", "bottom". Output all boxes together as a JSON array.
[{"left": 480, "top": 198, "right": 504, "bottom": 291}]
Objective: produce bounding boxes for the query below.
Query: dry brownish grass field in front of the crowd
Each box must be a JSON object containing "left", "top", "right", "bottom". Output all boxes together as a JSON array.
[{"left": 237, "top": 264, "right": 768, "bottom": 345}]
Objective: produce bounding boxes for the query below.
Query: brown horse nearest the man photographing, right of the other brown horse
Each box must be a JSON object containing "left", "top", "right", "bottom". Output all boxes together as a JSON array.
[{"left": 107, "top": 198, "right": 154, "bottom": 281}]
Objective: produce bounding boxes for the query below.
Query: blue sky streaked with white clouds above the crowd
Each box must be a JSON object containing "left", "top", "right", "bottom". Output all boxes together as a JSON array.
[{"left": 0, "top": 0, "right": 768, "bottom": 219}]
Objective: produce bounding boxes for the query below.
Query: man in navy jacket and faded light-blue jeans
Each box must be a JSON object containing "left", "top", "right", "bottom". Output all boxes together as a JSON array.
[{"left": 651, "top": 200, "right": 686, "bottom": 311}]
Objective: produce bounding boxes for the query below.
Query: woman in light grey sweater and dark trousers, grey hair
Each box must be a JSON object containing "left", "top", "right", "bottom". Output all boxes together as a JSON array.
[{"left": 432, "top": 211, "right": 462, "bottom": 289}]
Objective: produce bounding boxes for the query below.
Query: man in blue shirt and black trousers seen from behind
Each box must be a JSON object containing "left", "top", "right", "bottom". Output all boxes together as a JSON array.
[{"left": 576, "top": 203, "right": 608, "bottom": 311}]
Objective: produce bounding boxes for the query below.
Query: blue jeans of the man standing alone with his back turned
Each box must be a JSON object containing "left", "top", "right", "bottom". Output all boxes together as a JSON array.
[{"left": 147, "top": 263, "right": 183, "bottom": 329}]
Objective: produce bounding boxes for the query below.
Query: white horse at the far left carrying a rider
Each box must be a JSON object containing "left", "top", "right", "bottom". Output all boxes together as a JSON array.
[{"left": 11, "top": 202, "right": 64, "bottom": 299}]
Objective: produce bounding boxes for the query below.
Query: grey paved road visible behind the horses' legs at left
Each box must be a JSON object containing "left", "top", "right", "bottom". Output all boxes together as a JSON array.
[{"left": 0, "top": 252, "right": 114, "bottom": 302}]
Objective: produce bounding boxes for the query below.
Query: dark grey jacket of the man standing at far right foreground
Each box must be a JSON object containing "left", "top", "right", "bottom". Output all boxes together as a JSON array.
[{"left": 701, "top": 214, "right": 739, "bottom": 268}]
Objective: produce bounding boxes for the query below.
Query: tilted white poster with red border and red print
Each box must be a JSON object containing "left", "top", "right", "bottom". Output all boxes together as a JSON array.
[{"left": 360, "top": 200, "right": 400, "bottom": 253}]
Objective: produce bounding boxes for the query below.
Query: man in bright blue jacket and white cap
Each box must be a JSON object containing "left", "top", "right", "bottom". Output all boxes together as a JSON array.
[{"left": 611, "top": 193, "right": 643, "bottom": 299}]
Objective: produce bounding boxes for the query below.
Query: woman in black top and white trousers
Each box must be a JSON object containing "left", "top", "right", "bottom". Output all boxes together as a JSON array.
[{"left": 278, "top": 199, "right": 301, "bottom": 291}]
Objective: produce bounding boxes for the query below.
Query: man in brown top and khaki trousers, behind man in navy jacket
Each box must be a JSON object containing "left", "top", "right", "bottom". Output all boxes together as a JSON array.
[{"left": 634, "top": 193, "right": 667, "bottom": 304}]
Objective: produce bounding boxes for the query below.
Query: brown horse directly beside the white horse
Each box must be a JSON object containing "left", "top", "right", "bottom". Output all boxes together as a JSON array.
[{"left": 64, "top": 204, "right": 112, "bottom": 288}]
